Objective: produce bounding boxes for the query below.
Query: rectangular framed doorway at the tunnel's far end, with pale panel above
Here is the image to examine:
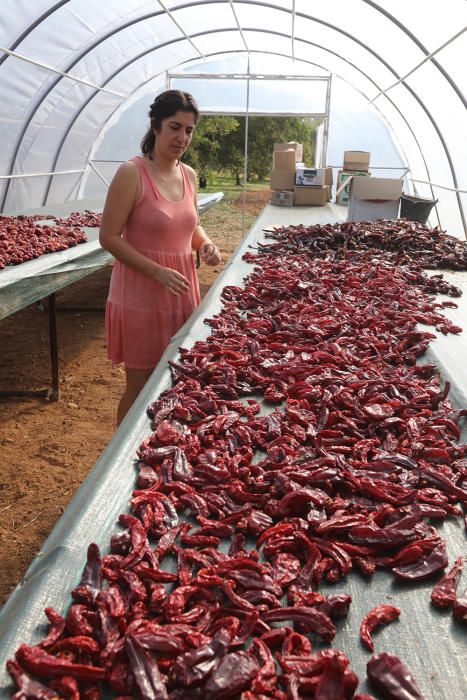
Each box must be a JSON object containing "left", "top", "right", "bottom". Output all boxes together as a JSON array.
[{"left": 166, "top": 70, "right": 331, "bottom": 236}]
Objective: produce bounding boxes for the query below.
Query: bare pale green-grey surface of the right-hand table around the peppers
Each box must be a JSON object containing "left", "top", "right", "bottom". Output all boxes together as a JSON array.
[{"left": 0, "top": 204, "right": 467, "bottom": 700}]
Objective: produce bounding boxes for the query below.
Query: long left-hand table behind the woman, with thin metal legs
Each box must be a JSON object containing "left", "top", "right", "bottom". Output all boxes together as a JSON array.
[{"left": 0, "top": 192, "right": 224, "bottom": 401}]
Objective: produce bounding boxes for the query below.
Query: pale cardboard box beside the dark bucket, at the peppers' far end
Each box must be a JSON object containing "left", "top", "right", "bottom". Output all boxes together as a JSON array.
[{"left": 347, "top": 176, "right": 402, "bottom": 221}]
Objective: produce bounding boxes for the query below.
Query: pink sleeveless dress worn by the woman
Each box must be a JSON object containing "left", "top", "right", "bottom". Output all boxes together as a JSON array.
[{"left": 105, "top": 156, "right": 200, "bottom": 369}]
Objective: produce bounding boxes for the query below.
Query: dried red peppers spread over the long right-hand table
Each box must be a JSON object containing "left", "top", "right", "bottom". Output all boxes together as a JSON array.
[{"left": 8, "top": 216, "right": 467, "bottom": 700}]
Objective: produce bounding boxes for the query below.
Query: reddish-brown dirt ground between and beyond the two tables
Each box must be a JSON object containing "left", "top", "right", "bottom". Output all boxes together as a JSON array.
[{"left": 0, "top": 190, "right": 268, "bottom": 605}]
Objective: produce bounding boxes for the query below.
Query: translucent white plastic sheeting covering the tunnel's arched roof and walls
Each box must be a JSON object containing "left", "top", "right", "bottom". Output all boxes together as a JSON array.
[{"left": 0, "top": 0, "right": 467, "bottom": 237}]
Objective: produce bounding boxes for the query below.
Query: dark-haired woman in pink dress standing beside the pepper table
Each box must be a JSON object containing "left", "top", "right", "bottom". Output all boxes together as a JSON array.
[{"left": 99, "top": 90, "right": 221, "bottom": 425}]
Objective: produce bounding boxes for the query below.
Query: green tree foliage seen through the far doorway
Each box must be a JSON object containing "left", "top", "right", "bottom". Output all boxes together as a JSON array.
[{"left": 186, "top": 116, "right": 320, "bottom": 184}]
